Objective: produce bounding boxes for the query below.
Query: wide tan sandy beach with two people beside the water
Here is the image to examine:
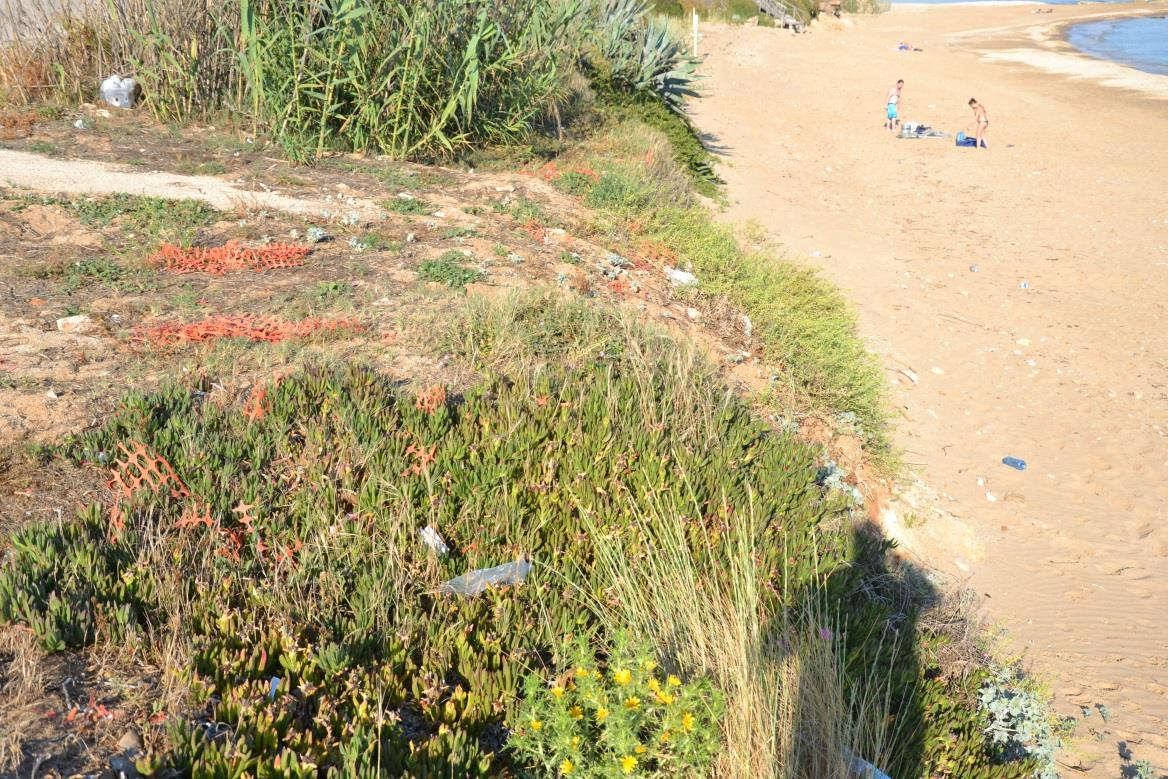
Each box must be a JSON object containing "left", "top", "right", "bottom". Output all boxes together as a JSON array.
[{"left": 695, "top": 4, "right": 1168, "bottom": 777}]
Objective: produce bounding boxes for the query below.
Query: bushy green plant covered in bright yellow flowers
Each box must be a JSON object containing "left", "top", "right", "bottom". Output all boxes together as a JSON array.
[{"left": 509, "top": 635, "right": 722, "bottom": 778}]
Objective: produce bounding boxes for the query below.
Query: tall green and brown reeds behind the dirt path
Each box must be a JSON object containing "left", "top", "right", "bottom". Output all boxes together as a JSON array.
[{"left": 0, "top": 0, "right": 583, "bottom": 159}]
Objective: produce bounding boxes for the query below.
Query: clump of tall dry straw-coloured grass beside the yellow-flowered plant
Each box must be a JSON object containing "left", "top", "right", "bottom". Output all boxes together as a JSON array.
[{"left": 582, "top": 483, "right": 892, "bottom": 779}]
